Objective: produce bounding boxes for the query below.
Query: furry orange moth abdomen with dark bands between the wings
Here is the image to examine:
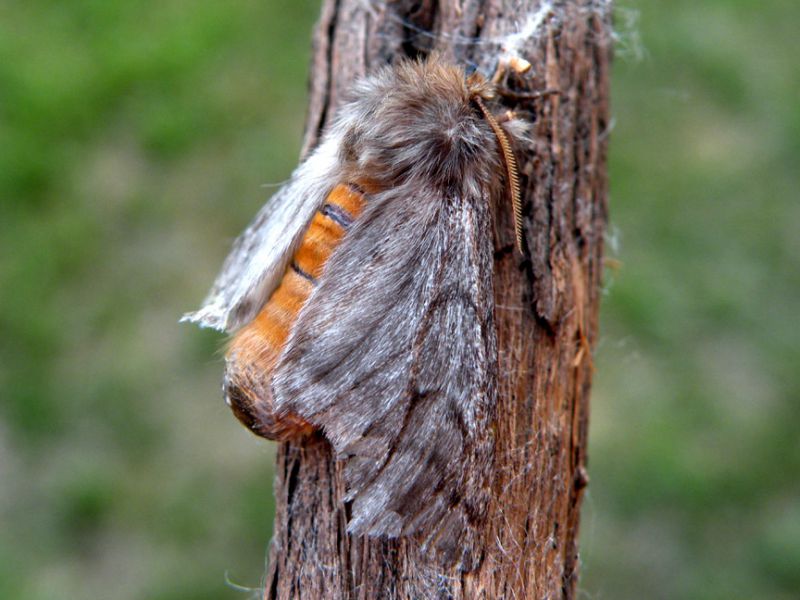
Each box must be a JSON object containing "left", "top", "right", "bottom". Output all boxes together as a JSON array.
[{"left": 223, "top": 184, "right": 365, "bottom": 440}]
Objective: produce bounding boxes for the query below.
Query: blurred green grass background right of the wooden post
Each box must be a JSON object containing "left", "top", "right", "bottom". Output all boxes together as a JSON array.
[{"left": 581, "top": 0, "right": 800, "bottom": 599}]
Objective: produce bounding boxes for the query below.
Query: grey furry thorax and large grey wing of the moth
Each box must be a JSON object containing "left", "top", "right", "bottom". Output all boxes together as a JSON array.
[{"left": 273, "top": 65, "right": 503, "bottom": 570}]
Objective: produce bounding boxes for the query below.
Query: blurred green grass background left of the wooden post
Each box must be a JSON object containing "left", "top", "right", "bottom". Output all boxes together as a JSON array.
[{"left": 0, "top": 0, "right": 318, "bottom": 600}]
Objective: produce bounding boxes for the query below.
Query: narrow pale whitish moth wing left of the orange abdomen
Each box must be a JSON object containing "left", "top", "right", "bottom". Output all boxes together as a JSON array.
[{"left": 181, "top": 135, "right": 339, "bottom": 331}]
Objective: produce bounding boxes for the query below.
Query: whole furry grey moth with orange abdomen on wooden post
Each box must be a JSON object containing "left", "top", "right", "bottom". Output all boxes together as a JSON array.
[{"left": 184, "top": 57, "right": 521, "bottom": 570}]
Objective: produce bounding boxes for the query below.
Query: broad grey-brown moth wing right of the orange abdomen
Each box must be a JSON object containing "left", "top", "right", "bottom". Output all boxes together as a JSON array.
[{"left": 273, "top": 183, "right": 497, "bottom": 569}]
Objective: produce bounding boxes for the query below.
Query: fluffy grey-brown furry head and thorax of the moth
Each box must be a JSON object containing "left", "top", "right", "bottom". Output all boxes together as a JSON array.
[{"left": 340, "top": 58, "right": 502, "bottom": 193}]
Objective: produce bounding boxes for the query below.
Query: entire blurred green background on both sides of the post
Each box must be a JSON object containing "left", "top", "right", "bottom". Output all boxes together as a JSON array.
[{"left": 0, "top": 0, "right": 800, "bottom": 600}]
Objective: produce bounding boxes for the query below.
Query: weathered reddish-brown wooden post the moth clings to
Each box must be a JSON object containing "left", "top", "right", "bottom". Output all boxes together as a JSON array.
[{"left": 264, "top": 0, "right": 611, "bottom": 599}]
